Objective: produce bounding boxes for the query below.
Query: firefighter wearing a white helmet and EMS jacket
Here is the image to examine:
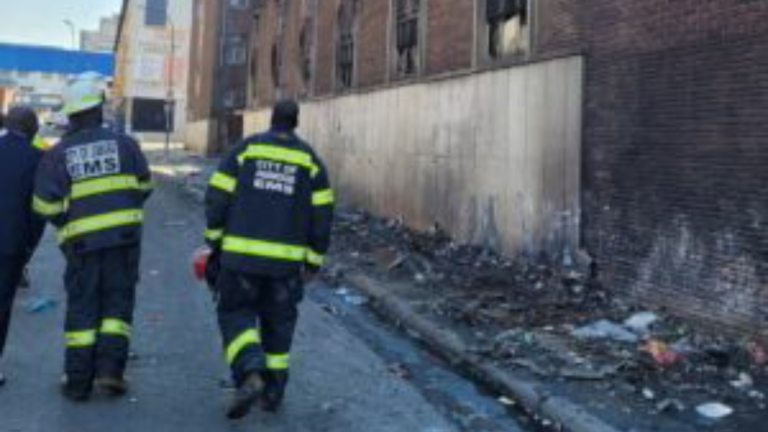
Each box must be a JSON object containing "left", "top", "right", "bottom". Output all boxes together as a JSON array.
[{"left": 34, "top": 74, "right": 151, "bottom": 401}]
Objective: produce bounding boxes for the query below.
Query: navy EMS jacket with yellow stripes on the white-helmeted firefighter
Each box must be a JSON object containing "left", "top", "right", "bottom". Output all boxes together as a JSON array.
[{"left": 34, "top": 119, "right": 152, "bottom": 254}]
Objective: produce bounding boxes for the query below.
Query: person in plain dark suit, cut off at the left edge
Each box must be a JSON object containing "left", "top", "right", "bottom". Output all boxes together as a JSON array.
[{"left": 0, "top": 108, "right": 45, "bottom": 385}]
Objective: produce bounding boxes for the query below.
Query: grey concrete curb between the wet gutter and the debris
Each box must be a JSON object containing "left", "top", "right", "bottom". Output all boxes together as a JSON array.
[{"left": 346, "top": 274, "right": 620, "bottom": 432}]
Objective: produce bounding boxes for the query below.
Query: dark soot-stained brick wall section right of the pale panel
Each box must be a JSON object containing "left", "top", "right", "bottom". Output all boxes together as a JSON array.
[{"left": 581, "top": 0, "right": 768, "bottom": 330}]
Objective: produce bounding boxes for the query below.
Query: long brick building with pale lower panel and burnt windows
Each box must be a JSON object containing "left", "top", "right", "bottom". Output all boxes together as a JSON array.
[{"left": 220, "top": 0, "right": 768, "bottom": 330}]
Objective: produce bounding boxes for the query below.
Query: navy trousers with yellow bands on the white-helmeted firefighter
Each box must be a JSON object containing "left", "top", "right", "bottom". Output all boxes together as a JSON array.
[{"left": 65, "top": 246, "right": 139, "bottom": 385}]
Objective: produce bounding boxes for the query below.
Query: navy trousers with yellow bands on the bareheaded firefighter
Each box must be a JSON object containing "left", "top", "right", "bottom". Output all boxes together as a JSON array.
[{"left": 217, "top": 269, "right": 303, "bottom": 384}]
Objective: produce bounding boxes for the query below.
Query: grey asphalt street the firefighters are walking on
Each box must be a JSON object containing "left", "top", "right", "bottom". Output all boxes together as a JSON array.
[{"left": 0, "top": 184, "right": 474, "bottom": 432}]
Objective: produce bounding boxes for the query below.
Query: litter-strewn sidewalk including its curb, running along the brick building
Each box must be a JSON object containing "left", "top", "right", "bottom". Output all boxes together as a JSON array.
[{"left": 153, "top": 145, "right": 768, "bottom": 432}]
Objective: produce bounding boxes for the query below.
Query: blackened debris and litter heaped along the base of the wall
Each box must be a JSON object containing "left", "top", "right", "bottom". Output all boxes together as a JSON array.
[{"left": 328, "top": 211, "right": 768, "bottom": 426}]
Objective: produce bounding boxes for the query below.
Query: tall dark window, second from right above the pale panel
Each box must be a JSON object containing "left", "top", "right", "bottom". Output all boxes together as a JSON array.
[{"left": 395, "top": 0, "right": 422, "bottom": 76}]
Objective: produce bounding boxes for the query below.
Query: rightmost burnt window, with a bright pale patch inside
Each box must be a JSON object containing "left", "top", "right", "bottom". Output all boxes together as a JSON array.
[{"left": 485, "top": 0, "right": 528, "bottom": 60}]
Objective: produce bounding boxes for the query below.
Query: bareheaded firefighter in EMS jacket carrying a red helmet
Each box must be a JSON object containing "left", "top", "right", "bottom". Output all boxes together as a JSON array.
[{"left": 205, "top": 101, "right": 334, "bottom": 419}]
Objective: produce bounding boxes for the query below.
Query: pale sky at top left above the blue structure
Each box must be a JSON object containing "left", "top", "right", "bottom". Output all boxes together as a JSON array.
[{"left": 0, "top": 0, "right": 122, "bottom": 48}]
